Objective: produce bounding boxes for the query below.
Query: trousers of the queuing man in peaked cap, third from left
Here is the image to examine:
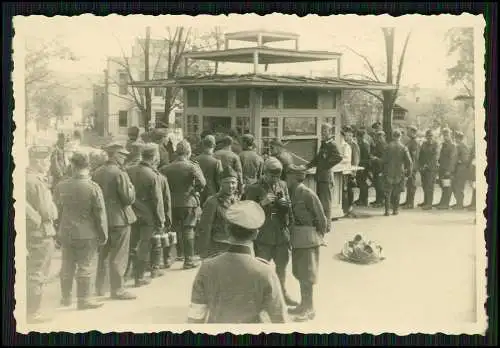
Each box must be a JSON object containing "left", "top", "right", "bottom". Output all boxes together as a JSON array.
[{"left": 96, "top": 226, "right": 131, "bottom": 295}]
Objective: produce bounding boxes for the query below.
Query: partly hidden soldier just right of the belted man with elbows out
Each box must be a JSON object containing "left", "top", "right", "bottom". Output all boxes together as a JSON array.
[{"left": 195, "top": 135, "right": 222, "bottom": 206}]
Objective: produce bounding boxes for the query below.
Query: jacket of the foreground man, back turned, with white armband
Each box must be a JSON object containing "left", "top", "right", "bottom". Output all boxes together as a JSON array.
[{"left": 188, "top": 245, "right": 286, "bottom": 324}]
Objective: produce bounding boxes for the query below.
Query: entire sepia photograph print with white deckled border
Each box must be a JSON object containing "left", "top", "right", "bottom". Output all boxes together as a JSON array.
[{"left": 12, "top": 13, "right": 488, "bottom": 335}]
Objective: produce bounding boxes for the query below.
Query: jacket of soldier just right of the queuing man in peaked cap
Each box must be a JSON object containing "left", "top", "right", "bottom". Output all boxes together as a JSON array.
[{"left": 127, "top": 162, "right": 165, "bottom": 227}]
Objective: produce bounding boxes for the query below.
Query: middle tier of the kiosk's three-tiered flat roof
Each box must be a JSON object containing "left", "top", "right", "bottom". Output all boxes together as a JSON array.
[{"left": 183, "top": 47, "right": 342, "bottom": 64}]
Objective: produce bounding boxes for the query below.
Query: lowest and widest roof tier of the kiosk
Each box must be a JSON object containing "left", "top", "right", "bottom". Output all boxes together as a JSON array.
[{"left": 131, "top": 74, "right": 396, "bottom": 90}]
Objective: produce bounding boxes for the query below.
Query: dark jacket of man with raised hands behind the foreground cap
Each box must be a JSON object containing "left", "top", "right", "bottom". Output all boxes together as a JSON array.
[{"left": 242, "top": 179, "right": 292, "bottom": 245}]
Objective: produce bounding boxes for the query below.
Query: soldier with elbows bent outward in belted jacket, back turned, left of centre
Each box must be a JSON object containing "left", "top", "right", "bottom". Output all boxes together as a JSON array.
[{"left": 160, "top": 140, "right": 206, "bottom": 269}]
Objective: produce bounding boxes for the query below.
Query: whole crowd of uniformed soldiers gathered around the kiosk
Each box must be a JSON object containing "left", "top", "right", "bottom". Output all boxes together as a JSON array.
[{"left": 26, "top": 124, "right": 476, "bottom": 323}]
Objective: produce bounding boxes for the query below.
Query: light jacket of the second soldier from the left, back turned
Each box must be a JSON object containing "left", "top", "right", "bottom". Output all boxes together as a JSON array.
[{"left": 54, "top": 173, "right": 108, "bottom": 240}]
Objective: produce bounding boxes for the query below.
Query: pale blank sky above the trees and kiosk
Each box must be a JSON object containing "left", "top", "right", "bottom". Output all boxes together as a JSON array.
[{"left": 14, "top": 14, "right": 482, "bottom": 88}]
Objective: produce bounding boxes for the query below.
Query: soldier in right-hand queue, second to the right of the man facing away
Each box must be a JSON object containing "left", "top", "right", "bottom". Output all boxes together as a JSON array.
[{"left": 418, "top": 129, "right": 438, "bottom": 210}]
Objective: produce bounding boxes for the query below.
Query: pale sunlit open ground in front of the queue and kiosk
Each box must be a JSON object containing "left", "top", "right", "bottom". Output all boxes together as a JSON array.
[{"left": 21, "top": 186, "right": 475, "bottom": 331}]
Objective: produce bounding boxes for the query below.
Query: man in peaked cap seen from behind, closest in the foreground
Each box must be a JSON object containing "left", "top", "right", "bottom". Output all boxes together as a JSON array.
[{"left": 188, "top": 201, "right": 286, "bottom": 324}]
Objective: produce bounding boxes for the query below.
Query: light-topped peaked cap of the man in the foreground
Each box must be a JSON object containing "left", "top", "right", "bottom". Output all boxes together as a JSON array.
[{"left": 225, "top": 200, "right": 266, "bottom": 230}]
